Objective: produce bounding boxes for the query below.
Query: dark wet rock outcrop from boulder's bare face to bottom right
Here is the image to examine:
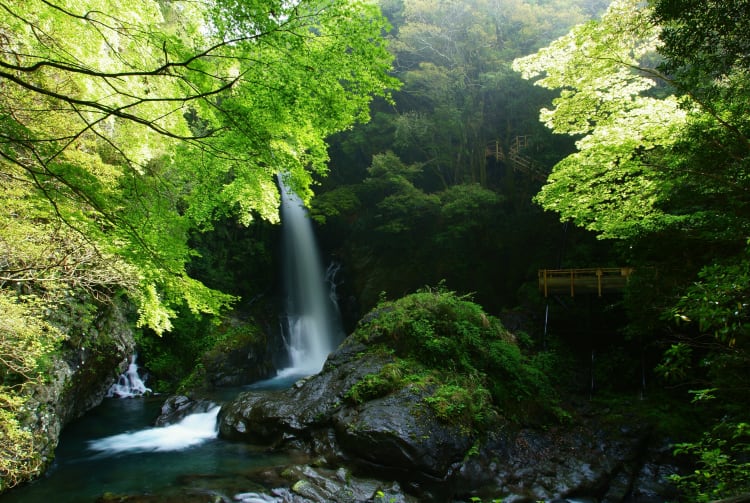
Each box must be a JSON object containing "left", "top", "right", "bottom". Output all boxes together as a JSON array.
[{"left": 219, "top": 343, "right": 688, "bottom": 503}]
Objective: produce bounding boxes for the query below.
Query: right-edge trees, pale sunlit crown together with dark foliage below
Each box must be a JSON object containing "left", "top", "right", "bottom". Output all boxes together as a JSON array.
[{"left": 514, "top": 0, "right": 750, "bottom": 501}]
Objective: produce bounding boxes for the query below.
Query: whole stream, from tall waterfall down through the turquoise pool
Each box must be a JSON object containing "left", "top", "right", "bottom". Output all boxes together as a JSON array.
[{"left": 0, "top": 177, "right": 344, "bottom": 503}]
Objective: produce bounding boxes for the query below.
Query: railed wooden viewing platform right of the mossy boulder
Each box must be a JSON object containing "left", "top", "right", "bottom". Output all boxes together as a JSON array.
[{"left": 539, "top": 267, "right": 634, "bottom": 297}]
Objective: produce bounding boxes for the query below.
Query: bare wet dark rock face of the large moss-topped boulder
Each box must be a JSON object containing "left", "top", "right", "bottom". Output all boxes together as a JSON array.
[{"left": 219, "top": 340, "right": 473, "bottom": 481}]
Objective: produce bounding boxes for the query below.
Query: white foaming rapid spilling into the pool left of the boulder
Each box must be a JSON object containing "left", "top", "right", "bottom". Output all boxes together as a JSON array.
[{"left": 88, "top": 406, "right": 221, "bottom": 454}]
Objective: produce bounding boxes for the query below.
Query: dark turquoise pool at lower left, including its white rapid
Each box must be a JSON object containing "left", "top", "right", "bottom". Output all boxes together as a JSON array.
[{"left": 0, "top": 377, "right": 306, "bottom": 503}]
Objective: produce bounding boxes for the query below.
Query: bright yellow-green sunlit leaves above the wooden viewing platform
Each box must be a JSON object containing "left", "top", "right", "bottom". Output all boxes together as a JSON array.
[{"left": 514, "top": 0, "right": 700, "bottom": 237}]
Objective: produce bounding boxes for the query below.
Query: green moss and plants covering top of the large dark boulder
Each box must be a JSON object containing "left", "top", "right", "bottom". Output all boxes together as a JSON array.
[{"left": 348, "top": 288, "right": 564, "bottom": 430}]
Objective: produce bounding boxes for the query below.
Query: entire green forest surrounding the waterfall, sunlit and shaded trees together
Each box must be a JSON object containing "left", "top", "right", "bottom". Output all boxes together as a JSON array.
[{"left": 0, "top": 0, "right": 750, "bottom": 501}]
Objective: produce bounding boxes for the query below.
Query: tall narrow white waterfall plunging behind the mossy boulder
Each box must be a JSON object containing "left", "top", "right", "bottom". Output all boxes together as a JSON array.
[{"left": 279, "top": 177, "right": 343, "bottom": 375}]
